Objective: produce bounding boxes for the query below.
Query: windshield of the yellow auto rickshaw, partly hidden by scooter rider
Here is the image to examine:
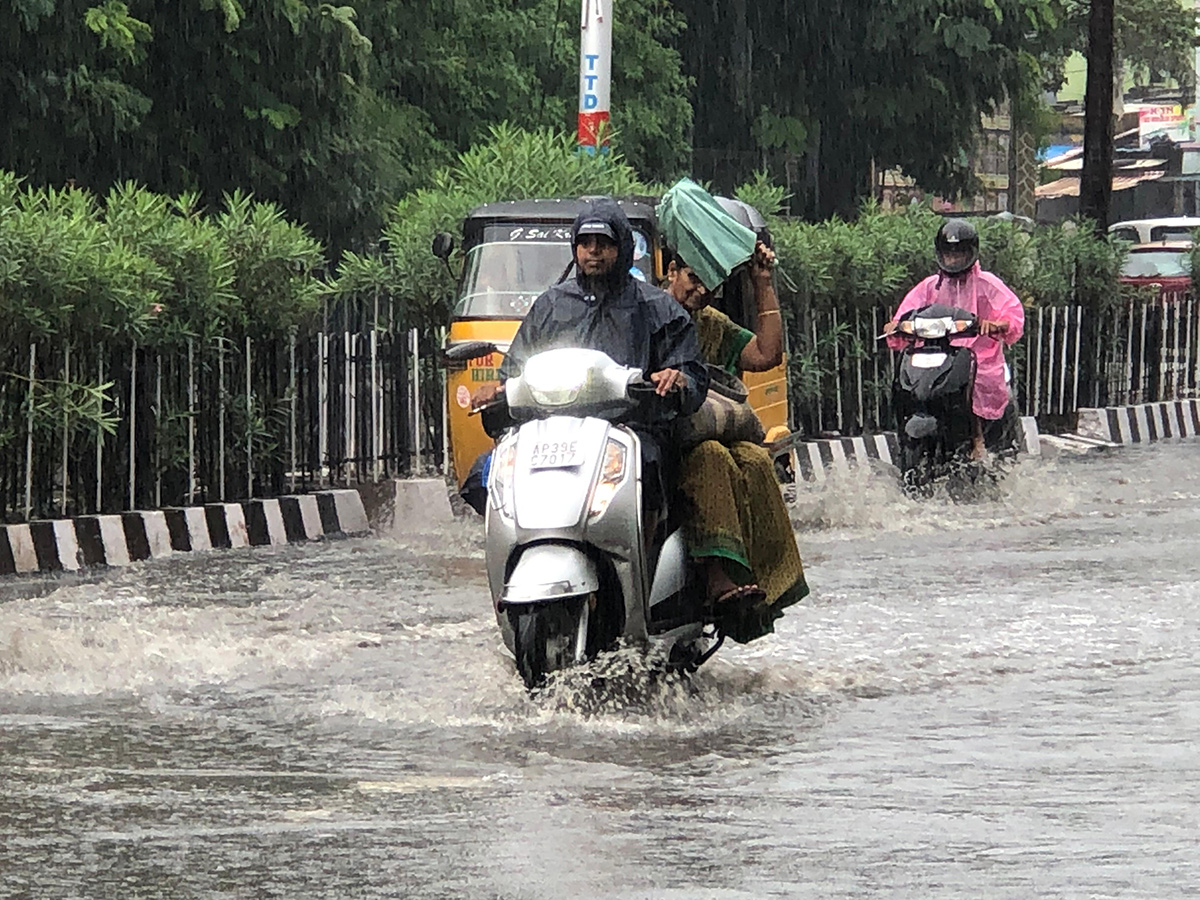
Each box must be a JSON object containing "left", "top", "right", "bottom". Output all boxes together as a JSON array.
[{"left": 454, "top": 228, "right": 653, "bottom": 319}]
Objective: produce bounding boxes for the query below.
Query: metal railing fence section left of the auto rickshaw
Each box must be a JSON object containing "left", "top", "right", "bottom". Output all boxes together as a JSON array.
[{"left": 0, "top": 329, "right": 443, "bottom": 521}]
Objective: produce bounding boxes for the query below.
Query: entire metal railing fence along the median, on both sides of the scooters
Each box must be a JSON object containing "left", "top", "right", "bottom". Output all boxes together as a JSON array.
[{"left": 0, "top": 293, "right": 1200, "bottom": 521}]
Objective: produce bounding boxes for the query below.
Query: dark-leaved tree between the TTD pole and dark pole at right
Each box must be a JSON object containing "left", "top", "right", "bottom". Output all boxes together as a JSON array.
[{"left": 678, "top": 0, "right": 1066, "bottom": 217}]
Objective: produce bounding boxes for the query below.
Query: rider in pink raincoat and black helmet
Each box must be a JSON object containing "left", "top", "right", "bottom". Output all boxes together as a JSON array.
[{"left": 884, "top": 218, "right": 1025, "bottom": 458}]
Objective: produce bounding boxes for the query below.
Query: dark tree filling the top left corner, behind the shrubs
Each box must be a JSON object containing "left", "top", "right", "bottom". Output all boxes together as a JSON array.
[{"left": 0, "top": 0, "right": 386, "bottom": 254}]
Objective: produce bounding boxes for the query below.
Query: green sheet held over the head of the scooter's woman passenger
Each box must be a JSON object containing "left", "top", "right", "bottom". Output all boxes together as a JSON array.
[{"left": 658, "top": 178, "right": 755, "bottom": 290}]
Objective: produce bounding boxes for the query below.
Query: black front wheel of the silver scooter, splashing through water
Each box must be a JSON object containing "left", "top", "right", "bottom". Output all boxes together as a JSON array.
[{"left": 509, "top": 596, "right": 590, "bottom": 689}]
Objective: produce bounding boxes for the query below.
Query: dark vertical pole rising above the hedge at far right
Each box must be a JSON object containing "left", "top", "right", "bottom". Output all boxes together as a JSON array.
[{"left": 1079, "top": 0, "right": 1114, "bottom": 234}]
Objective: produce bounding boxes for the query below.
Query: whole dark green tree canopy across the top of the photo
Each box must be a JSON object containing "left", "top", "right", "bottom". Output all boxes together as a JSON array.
[{"left": 0, "top": 0, "right": 1194, "bottom": 236}]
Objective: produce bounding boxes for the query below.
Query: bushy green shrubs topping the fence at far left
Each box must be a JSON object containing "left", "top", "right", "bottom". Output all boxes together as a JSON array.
[{"left": 0, "top": 173, "right": 325, "bottom": 346}]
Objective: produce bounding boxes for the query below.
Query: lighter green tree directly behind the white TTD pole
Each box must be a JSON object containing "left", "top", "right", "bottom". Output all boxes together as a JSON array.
[{"left": 359, "top": 0, "right": 691, "bottom": 186}]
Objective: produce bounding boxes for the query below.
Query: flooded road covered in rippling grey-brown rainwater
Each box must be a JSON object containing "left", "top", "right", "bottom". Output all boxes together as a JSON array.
[{"left": 0, "top": 443, "right": 1200, "bottom": 900}]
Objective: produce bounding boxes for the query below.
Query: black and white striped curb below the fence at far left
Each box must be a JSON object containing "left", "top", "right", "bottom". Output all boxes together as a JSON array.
[{"left": 0, "top": 490, "right": 371, "bottom": 575}]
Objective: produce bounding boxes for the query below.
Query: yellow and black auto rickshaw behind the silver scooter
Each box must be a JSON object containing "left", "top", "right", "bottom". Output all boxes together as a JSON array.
[{"left": 434, "top": 198, "right": 788, "bottom": 487}]
